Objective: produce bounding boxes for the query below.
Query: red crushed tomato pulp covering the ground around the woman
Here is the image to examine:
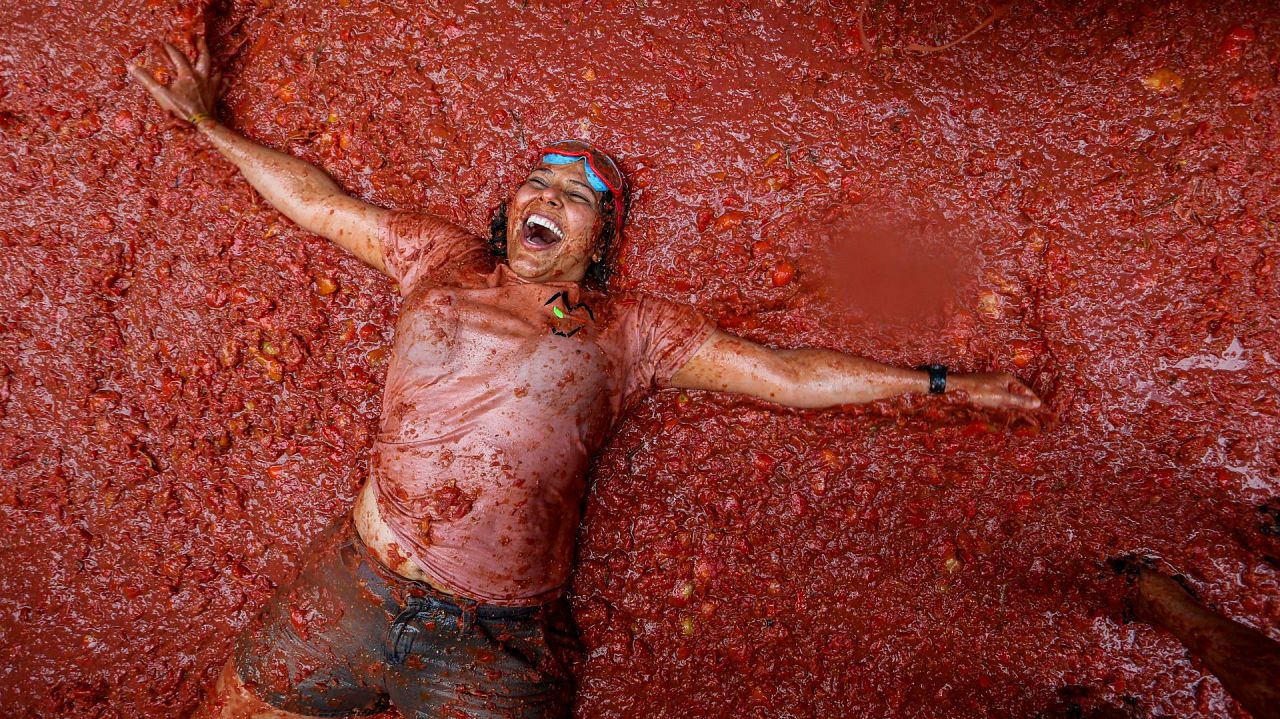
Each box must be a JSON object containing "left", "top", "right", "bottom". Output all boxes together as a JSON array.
[{"left": 0, "top": 0, "right": 1280, "bottom": 718}]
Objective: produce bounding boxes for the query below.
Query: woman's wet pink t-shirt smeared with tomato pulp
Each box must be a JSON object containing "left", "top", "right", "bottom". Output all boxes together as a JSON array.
[{"left": 370, "top": 212, "right": 714, "bottom": 605}]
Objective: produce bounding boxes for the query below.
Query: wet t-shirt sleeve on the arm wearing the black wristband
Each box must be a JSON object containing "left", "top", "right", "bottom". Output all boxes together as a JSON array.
[{"left": 627, "top": 294, "right": 716, "bottom": 391}]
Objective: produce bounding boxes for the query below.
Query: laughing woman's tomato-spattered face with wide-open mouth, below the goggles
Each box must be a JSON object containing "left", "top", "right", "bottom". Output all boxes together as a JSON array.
[{"left": 507, "top": 161, "right": 604, "bottom": 281}]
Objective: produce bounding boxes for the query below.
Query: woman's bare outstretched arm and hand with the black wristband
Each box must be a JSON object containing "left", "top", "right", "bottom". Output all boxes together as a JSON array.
[{"left": 671, "top": 331, "right": 1041, "bottom": 409}]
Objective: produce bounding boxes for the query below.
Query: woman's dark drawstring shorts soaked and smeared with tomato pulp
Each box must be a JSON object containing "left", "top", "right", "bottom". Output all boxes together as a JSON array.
[{"left": 236, "top": 518, "right": 581, "bottom": 719}]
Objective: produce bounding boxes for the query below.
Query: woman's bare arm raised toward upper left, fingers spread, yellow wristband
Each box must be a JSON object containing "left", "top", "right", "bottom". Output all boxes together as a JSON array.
[{"left": 129, "top": 38, "right": 390, "bottom": 273}]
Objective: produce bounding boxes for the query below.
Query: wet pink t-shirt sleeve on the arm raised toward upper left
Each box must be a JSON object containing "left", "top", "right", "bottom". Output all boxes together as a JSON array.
[{"left": 383, "top": 211, "right": 486, "bottom": 297}]
